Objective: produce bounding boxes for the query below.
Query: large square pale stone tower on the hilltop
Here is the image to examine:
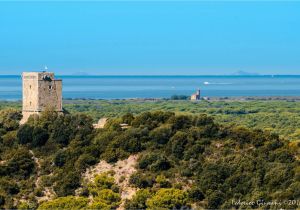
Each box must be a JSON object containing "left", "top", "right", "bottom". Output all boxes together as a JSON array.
[{"left": 21, "top": 72, "right": 63, "bottom": 123}]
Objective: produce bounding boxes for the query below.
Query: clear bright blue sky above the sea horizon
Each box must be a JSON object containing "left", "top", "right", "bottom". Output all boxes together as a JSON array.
[{"left": 0, "top": 1, "right": 300, "bottom": 75}]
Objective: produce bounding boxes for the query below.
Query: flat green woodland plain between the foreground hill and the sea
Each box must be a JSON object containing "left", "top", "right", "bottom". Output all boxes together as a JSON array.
[{"left": 0, "top": 96, "right": 300, "bottom": 141}]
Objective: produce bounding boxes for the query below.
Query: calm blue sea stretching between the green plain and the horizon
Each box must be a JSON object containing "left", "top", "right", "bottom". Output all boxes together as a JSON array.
[{"left": 0, "top": 75, "right": 300, "bottom": 100}]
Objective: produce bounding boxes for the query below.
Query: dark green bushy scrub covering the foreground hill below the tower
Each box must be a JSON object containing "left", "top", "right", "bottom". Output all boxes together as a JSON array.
[{"left": 0, "top": 107, "right": 300, "bottom": 209}]
